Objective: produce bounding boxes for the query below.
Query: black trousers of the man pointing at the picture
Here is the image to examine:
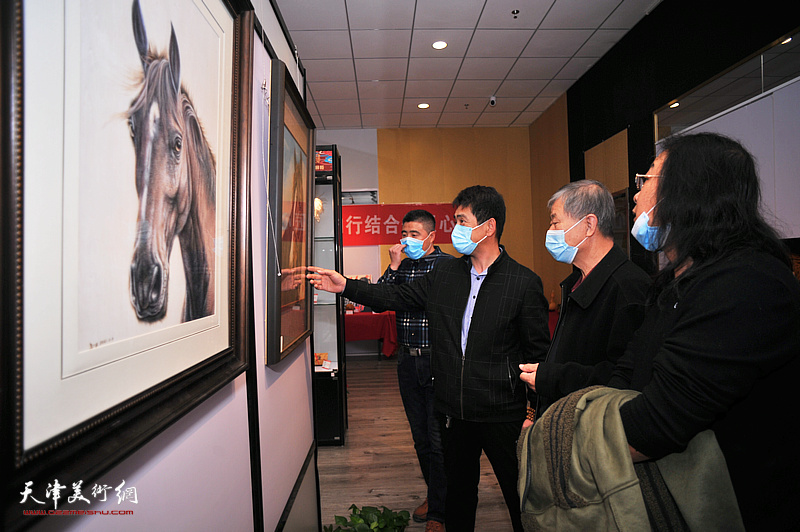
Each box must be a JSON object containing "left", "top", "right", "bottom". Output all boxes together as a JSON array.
[{"left": 440, "top": 416, "right": 522, "bottom": 532}]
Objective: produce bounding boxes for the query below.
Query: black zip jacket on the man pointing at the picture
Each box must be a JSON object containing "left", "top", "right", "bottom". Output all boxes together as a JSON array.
[{"left": 343, "top": 250, "right": 550, "bottom": 422}]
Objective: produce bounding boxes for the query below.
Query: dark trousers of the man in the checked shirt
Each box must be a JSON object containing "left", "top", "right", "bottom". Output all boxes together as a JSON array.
[{"left": 397, "top": 348, "right": 447, "bottom": 522}]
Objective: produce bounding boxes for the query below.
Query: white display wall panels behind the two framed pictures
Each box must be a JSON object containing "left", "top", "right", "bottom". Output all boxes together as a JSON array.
[{"left": 27, "top": 0, "right": 318, "bottom": 532}]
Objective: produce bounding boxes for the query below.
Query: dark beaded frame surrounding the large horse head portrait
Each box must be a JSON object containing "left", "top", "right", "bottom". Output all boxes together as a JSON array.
[{"left": 0, "top": 0, "right": 254, "bottom": 530}]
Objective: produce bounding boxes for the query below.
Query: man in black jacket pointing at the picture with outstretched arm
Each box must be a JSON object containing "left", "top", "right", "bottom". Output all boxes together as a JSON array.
[{"left": 309, "top": 186, "right": 550, "bottom": 531}]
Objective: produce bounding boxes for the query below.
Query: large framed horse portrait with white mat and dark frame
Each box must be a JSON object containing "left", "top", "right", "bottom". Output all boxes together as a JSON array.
[{"left": 0, "top": 0, "right": 254, "bottom": 529}]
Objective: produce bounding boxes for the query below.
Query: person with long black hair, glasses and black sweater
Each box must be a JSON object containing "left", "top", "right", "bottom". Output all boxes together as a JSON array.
[{"left": 609, "top": 133, "right": 800, "bottom": 530}]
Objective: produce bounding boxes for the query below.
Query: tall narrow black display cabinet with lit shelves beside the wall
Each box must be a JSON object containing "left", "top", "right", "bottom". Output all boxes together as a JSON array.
[{"left": 311, "top": 145, "right": 347, "bottom": 445}]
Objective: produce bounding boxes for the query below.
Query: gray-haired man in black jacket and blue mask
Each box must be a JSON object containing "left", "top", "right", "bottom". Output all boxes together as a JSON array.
[{"left": 520, "top": 180, "right": 651, "bottom": 424}]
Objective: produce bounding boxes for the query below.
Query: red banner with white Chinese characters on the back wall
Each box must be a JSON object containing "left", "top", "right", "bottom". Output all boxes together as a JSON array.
[{"left": 342, "top": 203, "right": 455, "bottom": 246}]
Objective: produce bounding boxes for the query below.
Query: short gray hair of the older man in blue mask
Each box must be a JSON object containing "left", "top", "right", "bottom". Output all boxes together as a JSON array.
[{"left": 547, "top": 179, "right": 614, "bottom": 238}]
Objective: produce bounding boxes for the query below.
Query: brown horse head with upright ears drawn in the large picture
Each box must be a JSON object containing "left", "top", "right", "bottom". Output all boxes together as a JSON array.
[{"left": 127, "top": 0, "right": 216, "bottom": 322}]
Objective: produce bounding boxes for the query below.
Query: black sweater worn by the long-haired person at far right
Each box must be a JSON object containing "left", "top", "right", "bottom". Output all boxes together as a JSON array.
[{"left": 609, "top": 251, "right": 800, "bottom": 530}]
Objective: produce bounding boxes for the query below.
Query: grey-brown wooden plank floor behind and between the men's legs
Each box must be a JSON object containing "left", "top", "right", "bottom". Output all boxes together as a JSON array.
[{"left": 318, "top": 355, "right": 511, "bottom": 532}]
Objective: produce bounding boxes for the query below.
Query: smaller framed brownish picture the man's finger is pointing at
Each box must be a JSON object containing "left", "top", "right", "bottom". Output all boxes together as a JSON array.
[{"left": 266, "top": 59, "right": 314, "bottom": 364}]
